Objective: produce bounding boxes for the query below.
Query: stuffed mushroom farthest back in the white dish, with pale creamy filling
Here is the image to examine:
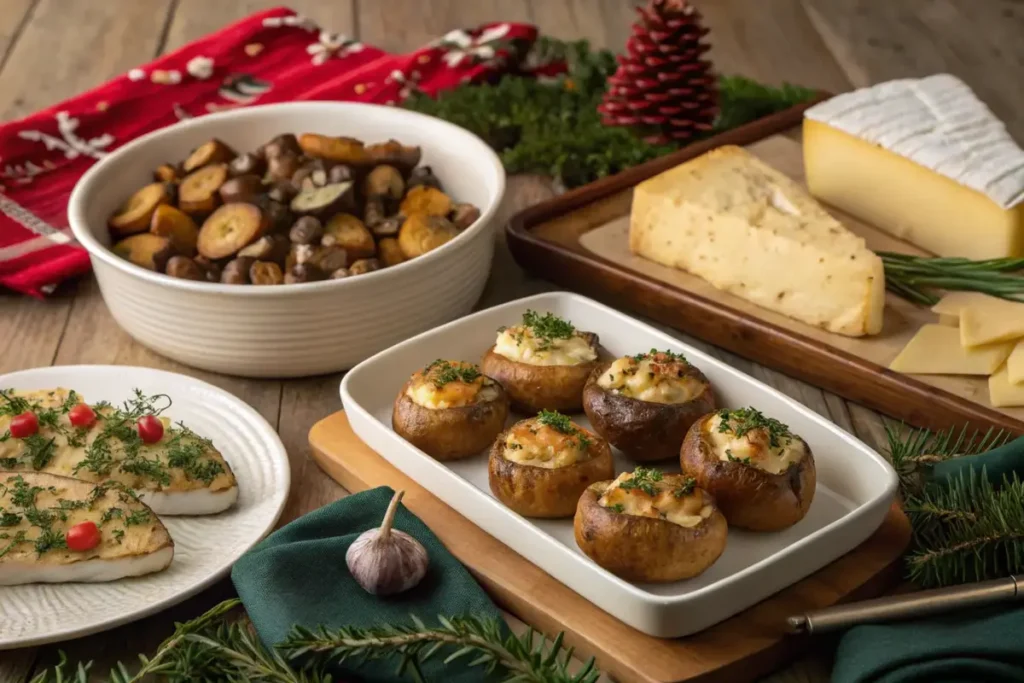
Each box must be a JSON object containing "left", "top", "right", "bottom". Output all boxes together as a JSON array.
[{"left": 482, "top": 310, "right": 598, "bottom": 413}]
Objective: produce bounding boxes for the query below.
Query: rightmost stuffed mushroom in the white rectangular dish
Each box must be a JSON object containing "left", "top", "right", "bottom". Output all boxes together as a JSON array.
[{"left": 679, "top": 408, "right": 816, "bottom": 531}]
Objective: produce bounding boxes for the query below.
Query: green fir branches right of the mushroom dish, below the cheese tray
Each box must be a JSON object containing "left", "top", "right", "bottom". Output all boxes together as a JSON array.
[{"left": 886, "top": 424, "right": 1024, "bottom": 588}]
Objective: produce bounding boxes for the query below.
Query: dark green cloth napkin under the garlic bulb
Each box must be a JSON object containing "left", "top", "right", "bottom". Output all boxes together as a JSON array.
[{"left": 231, "top": 486, "right": 501, "bottom": 683}]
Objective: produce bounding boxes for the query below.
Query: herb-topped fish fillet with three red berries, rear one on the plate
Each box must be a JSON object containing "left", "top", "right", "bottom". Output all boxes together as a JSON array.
[{"left": 0, "top": 389, "right": 239, "bottom": 515}]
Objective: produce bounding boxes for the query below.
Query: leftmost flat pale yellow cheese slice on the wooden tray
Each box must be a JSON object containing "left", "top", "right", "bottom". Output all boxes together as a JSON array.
[{"left": 889, "top": 325, "right": 1014, "bottom": 375}]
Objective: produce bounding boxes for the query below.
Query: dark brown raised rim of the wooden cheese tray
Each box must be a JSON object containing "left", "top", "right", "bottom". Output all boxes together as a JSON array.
[{"left": 506, "top": 105, "right": 1024, "bottom": 434}]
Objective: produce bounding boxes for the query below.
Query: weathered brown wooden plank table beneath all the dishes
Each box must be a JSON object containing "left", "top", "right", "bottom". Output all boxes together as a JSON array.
[{"left": 0, "top": 0, "right": 1024, "bottom": 683}]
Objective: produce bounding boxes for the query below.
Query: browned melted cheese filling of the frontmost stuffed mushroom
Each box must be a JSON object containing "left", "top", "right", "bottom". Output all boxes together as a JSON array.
[{"left": 597, "top": 472, "right": 715, "bottom": 527}]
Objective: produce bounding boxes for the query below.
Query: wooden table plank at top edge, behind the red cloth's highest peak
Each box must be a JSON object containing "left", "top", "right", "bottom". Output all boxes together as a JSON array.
[{"left": 165, "top": 0, "right": 355, "bottom": 51}]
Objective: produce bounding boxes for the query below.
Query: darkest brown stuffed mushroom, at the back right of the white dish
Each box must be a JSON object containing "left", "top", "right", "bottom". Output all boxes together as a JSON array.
[{"left": 583, "top": 349, "right": 716, "bottom": 462}]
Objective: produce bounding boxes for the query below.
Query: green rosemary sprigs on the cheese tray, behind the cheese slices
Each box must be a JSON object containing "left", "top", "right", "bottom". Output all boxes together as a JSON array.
[{"left": 878, "top": 252, "right": 1024, "bottom": 306}]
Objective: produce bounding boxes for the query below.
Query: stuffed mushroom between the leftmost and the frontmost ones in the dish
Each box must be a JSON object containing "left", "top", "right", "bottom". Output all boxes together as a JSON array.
[{"left": 487, "top": 411, "right": 615, "bottom": 518}]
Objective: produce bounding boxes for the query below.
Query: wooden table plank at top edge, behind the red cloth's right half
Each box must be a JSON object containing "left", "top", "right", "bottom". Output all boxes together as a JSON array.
[{"left": 356, "top": 0, "right": 530, "bottom": 51}]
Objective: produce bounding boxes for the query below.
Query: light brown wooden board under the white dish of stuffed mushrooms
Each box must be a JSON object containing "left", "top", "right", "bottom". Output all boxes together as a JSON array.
[{"left": 309, "top": 412, "right": 910, "bottom": 683}]
